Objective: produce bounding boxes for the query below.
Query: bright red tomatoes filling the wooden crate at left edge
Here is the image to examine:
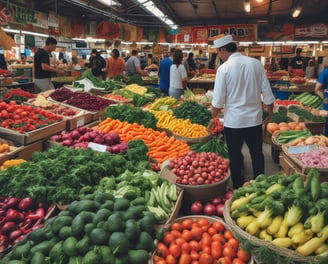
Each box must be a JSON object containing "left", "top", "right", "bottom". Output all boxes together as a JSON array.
[{"left": 0, "top": 101, "right": 63, "bottom": 133}]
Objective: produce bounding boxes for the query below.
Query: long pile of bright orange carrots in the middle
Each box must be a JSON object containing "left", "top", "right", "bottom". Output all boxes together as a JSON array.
[{"left": 96, "top": 117, "right": 190, "bottom": 164}]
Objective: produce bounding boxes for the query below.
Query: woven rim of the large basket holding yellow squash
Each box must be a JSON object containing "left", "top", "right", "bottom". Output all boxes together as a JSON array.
[{"left": 223, "top": 198, "right": 320, "bottom": 264}]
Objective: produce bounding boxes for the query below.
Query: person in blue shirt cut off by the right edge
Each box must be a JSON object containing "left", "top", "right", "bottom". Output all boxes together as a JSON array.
[{"left": 314, "top": 57, "right": 328, "bottom": 136}]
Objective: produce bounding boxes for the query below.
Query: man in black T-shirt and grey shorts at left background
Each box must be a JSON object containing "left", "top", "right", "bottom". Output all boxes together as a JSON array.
[{"left": 34, "top": 37, "right": 65, "bottom": 93}]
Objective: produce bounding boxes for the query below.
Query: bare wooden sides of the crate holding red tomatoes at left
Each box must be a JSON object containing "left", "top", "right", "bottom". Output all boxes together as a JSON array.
[{"left": 0, "top": 120, "right": 66, "bottom": 145}]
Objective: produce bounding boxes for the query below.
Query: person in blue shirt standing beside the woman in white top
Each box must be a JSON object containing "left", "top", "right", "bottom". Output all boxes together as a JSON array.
[{"left": 158, "top": 48, "right": 175, "bottom": 95}]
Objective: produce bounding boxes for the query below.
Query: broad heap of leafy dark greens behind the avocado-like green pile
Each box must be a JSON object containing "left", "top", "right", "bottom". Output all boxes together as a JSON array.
[{"left": 0, "top": 145, "right": 138, "bottom": 204}]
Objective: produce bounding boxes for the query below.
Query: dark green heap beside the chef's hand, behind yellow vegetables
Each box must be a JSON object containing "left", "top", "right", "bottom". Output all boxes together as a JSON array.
[{"left": 173, "top": 101, "right": 212, "bottom": 127}]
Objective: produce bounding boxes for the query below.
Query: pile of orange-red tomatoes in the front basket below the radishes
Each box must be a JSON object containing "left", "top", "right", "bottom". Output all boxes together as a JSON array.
[{"left": 153, "top": 217, "right": 250, "bottom": 264}]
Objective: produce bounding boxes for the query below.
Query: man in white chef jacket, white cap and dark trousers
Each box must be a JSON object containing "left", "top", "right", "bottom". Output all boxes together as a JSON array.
[{"left": 208, "top": 35, "right": 275, "bottom": 188}]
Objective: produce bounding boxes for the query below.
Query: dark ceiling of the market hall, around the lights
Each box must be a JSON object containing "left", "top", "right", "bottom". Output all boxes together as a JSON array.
[{"left": 7, "top": 0, "right": 328, "bottom": 28}]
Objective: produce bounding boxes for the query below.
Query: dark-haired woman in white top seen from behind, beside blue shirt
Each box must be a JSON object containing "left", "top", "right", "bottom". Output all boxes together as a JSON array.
[{"left": 169, "top": 49, "right": 188, "bottom": 99}]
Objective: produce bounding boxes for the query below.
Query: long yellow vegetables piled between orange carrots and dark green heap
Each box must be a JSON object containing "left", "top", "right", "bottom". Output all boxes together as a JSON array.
[{"left": 151, "top": 111, "right": 208, "bottom": 138}]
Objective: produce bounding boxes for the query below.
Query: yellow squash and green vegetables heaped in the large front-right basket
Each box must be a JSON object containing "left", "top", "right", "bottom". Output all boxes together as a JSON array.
[{"left": 230, "top": 169, "right": 328, "bottom": 258}]
